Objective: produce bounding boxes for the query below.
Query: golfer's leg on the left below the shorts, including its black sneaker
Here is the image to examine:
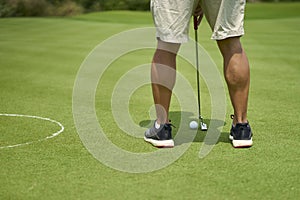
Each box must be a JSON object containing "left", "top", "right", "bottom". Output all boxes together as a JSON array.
[{"left": 144, "top": 40, "right": 180, "bottom": 147}]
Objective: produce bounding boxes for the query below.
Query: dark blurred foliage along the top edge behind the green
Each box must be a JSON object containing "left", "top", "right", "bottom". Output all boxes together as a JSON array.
[{"left": 0, "top": 0, "right": 300, "bottom": 17}]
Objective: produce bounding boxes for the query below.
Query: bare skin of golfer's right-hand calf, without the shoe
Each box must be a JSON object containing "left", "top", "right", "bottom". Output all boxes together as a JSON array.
[{"left": 217, "top": 37, "right": 250, "bottom": 124}]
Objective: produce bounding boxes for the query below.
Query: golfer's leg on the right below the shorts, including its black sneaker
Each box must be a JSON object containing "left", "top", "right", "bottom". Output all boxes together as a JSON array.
[{"left": 217, "top": 37, "right": 252, "bottom": 147}]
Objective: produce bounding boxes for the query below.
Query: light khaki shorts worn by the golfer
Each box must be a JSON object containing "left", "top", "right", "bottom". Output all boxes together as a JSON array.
[{"left": 151, "top": 0, "right": 246, "bottom": 43}]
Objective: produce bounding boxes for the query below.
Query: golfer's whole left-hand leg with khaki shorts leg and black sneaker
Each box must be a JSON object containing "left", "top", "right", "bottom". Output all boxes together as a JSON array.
[{"left": 148, "top": 0, "right": 194, "bottom": 147}]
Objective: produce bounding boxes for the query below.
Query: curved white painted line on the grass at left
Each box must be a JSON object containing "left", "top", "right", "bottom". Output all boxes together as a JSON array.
[{"left": 0, "top": 113, "right": 65, "bottom": 149}]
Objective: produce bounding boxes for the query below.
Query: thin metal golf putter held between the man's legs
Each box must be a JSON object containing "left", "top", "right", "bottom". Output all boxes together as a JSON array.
[{"left": 194, "top": 15, "right": 207, "bottom": 131}]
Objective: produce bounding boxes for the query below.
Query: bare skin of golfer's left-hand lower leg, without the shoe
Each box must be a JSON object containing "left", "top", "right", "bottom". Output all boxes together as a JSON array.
[{"left": 151, "top": 40, "right": 180, "bottom": 124}]
